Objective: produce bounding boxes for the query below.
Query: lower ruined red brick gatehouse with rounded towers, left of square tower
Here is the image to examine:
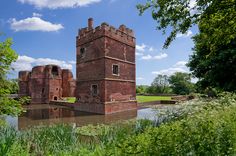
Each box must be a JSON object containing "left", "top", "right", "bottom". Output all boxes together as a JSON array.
[{"left": 19, "top": 65, "right": 76, "bottom": 104}]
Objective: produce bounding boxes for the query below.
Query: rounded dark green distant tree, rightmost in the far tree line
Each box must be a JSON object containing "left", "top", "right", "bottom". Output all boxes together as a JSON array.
[{"left": 169, "top": 72, "right": 194, "bottom": 95}]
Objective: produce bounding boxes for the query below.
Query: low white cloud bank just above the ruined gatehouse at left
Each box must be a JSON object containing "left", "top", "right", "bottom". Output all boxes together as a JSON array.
[{"left": 12, "top": 55, "right": 74, "bottom": 71}]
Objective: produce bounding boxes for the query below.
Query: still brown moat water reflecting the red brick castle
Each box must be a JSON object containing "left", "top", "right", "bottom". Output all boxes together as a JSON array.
[{"left": 2, "top": 104, "right": 162, "bottom": 130}]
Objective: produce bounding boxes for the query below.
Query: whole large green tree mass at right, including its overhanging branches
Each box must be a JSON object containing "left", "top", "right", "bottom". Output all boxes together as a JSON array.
[{"left": 137, "top": 0, "right": 236, "bottom": 91}]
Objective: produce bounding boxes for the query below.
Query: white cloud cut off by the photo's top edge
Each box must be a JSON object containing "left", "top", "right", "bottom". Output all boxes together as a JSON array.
[{"left": 18, "top": 0, "right": 101, "bottom": 9}]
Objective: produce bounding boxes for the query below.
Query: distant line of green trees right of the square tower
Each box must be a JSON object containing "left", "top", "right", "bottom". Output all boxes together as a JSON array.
[{"left": 136, "top": 72, "right": 195, "bottom": 95}]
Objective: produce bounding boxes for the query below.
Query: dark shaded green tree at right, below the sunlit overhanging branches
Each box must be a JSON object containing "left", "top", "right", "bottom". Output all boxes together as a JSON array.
[{"left": 188, "top": 35, "right": 236, "bottom": 91}]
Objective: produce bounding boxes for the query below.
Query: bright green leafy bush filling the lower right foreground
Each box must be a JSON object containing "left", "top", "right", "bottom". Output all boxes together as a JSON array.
[{"left": 118, "top": 95, "right": 236, "bottom": 155}]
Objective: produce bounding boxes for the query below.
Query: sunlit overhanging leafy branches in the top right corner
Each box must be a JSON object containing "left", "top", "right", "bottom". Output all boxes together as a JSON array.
[{"left": 137, "top": 0, "right": 236, "bottom": 51}]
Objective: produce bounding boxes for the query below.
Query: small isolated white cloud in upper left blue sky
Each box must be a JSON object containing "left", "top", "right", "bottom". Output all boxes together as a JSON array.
[{"left": 10, "top": 17, "right": 64, "bottom": 32}]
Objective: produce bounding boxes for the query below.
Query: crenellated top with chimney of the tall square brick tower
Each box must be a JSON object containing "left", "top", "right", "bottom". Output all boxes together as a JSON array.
[{"left": 76, "top": 18, "right": 135, "bottom": 47}]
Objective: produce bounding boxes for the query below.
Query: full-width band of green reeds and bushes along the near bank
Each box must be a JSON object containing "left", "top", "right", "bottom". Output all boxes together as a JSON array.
[{"left": 0, "top": 94, "right": 236, "bottom": 156}]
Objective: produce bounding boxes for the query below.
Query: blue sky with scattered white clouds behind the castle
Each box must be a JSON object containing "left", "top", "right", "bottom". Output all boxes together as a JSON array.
[{"left": 0, "top": 0, "right": 197, "bottom": 85}]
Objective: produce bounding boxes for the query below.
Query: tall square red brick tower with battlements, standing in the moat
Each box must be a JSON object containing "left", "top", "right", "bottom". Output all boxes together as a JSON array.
[{"left": 76, "top": 18, "right": 137, "bottom": 114}]
